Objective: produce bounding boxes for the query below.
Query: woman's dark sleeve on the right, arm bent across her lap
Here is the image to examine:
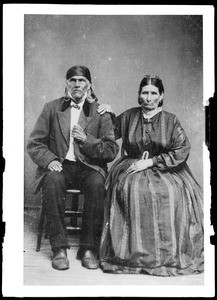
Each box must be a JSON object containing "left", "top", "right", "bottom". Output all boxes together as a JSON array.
[{"left": 152, "top": 117, "right": 191, "bottom": 170}]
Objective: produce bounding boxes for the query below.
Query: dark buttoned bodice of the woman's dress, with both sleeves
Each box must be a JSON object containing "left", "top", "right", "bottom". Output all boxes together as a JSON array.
[{"left": 115, "top": 107, "right": 190, "bottom": 167}]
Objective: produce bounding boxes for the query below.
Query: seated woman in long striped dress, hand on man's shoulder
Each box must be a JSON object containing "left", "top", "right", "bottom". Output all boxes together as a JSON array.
[{"left": 98, "top": 76, "right": 204, "bottom": 276}]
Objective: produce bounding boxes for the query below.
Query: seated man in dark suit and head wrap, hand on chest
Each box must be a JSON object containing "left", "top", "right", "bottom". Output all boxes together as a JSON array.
[{"left": 27, "top": 66, "right": 118, "bottom": 270}]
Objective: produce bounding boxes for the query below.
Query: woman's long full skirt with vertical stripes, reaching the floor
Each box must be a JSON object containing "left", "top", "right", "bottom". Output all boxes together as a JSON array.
[{"left": 100, "top": 158, "right": 204, "bottom": 276}]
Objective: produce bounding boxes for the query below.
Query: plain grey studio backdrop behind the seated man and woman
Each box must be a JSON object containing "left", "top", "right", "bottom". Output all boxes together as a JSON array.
[{"left": 24, "top": 15, "right": 205, "bottom": 206}]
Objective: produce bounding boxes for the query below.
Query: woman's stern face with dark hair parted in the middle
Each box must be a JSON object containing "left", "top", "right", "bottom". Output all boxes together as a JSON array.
[{"left": 139, "top": 84, "right": 163, "bottom": 110}]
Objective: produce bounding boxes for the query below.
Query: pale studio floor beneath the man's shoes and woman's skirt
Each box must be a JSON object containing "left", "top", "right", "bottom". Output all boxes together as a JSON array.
[{"left": 24, "top": 211, "right": 204, "bottom": 286}]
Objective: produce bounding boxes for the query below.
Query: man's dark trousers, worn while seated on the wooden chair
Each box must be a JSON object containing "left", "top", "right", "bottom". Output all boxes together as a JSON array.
[{"left": 42, "top": 160, "right": 105, "bottom": 254}]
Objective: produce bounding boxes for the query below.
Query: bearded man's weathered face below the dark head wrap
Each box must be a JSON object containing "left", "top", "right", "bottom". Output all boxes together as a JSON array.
[{"left": 67, "top": 76, "right": 90, "bottom": 102}]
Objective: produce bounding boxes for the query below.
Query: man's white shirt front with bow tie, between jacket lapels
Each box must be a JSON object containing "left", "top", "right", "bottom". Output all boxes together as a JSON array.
[{"left": 66, "top": 101, "right": 84, "bottom": 161}]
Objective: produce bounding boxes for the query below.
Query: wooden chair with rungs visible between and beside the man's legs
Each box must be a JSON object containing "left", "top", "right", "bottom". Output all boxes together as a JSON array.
[{"left": 36, "top": 189, "right": 82, "bottom": 252}]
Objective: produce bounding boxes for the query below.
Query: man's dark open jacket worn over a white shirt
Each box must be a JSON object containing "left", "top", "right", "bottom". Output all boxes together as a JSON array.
[{"left": 27, "top": 97, "right": 119, "bottom": 193}]
